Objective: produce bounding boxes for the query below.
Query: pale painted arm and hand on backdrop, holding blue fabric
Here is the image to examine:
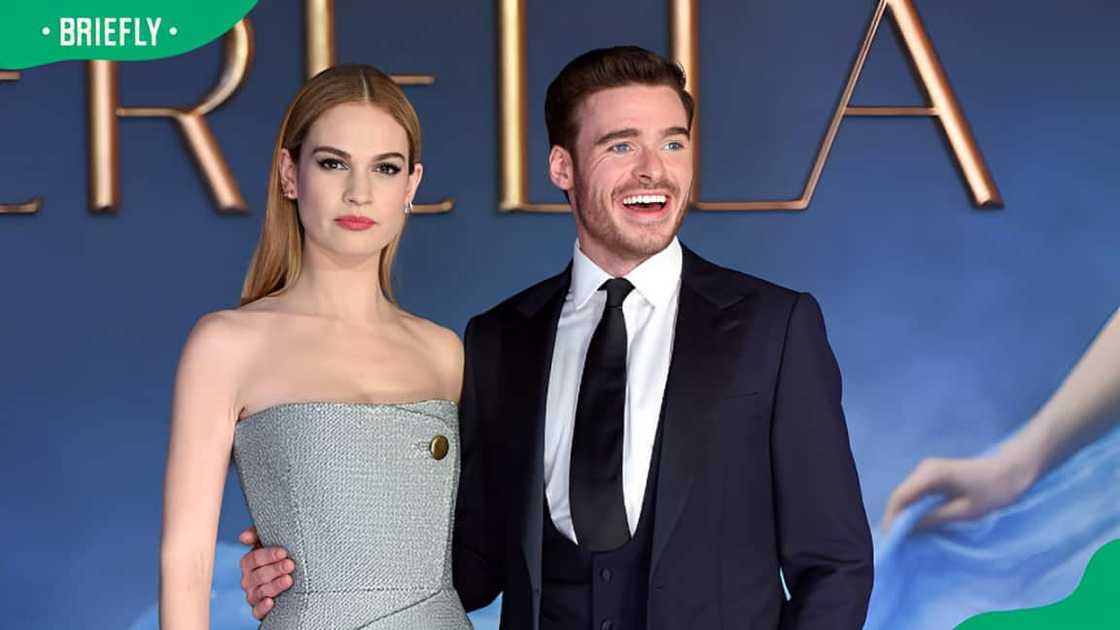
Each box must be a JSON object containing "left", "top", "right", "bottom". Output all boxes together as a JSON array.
[{"left": 883, "top": 312, "right": 1120, "bottom": 529}]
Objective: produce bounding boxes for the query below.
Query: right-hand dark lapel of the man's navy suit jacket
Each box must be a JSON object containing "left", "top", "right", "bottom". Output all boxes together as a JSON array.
[{"left": 650, "top": 248, "right": 744, "bottom": 577}]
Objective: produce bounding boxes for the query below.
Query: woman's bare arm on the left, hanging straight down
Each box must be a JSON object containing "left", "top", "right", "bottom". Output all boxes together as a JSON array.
[{"left": 159, "top": 313, "right": 239, "bottom": 630}]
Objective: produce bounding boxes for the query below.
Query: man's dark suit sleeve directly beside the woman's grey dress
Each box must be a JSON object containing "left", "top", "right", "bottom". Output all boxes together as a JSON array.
[{"left": 451, "top": 317, "right": 505, "bottom": 610}]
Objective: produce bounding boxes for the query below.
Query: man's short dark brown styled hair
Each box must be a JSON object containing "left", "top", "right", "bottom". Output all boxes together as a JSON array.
[{"left": 544, "top": 46, "right": 693, "bottom": 151}]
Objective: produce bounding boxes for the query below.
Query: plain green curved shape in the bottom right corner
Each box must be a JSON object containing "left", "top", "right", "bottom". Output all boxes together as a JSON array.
[{"left": 956, "top": 539, "right": 1120, "bottom": 630}]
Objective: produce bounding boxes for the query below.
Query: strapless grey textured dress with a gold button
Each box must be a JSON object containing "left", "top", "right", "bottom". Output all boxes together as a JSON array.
[{"left": 233, "top": 400, "right": 470, "bottom": 630}]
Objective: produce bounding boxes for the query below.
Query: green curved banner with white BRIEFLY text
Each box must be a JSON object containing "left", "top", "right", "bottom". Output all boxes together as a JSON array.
[{"left": 0, "top": 0, "right": 256, "bottom": 70}]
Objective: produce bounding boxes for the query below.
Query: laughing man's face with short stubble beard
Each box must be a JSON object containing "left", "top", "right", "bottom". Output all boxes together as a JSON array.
[{"left": 550, "top": 85, "right": 692, "bottom": 265}]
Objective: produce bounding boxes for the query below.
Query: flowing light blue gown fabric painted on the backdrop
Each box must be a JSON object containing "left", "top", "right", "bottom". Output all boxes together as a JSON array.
[{"left": 864, "top": 428, "right": 1120, "bottom": 630}]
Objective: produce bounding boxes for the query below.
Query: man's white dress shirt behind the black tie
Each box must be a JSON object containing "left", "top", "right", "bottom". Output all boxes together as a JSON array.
[{"left": 544, "top": 238, "right": 682, "bottom": 543}]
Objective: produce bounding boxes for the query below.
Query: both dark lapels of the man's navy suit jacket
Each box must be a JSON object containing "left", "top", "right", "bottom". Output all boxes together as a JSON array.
[{"left": 506, "top": 248, "right": 745, "bottom": 591}]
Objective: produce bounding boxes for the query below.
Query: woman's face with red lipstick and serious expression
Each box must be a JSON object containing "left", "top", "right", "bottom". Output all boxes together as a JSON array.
[{"left": 280, "top": 103, "right": 422, "bottom": 262}]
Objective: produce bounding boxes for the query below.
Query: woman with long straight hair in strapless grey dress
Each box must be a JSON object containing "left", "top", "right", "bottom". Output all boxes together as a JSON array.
[{"left": 160, "top": 66, "right": 470, "bottom": 630}]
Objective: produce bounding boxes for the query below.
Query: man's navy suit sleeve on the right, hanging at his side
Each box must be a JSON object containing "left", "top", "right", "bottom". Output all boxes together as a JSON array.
[{"left": 771, "top": 294, "right": 874, "bottom": 630}]
